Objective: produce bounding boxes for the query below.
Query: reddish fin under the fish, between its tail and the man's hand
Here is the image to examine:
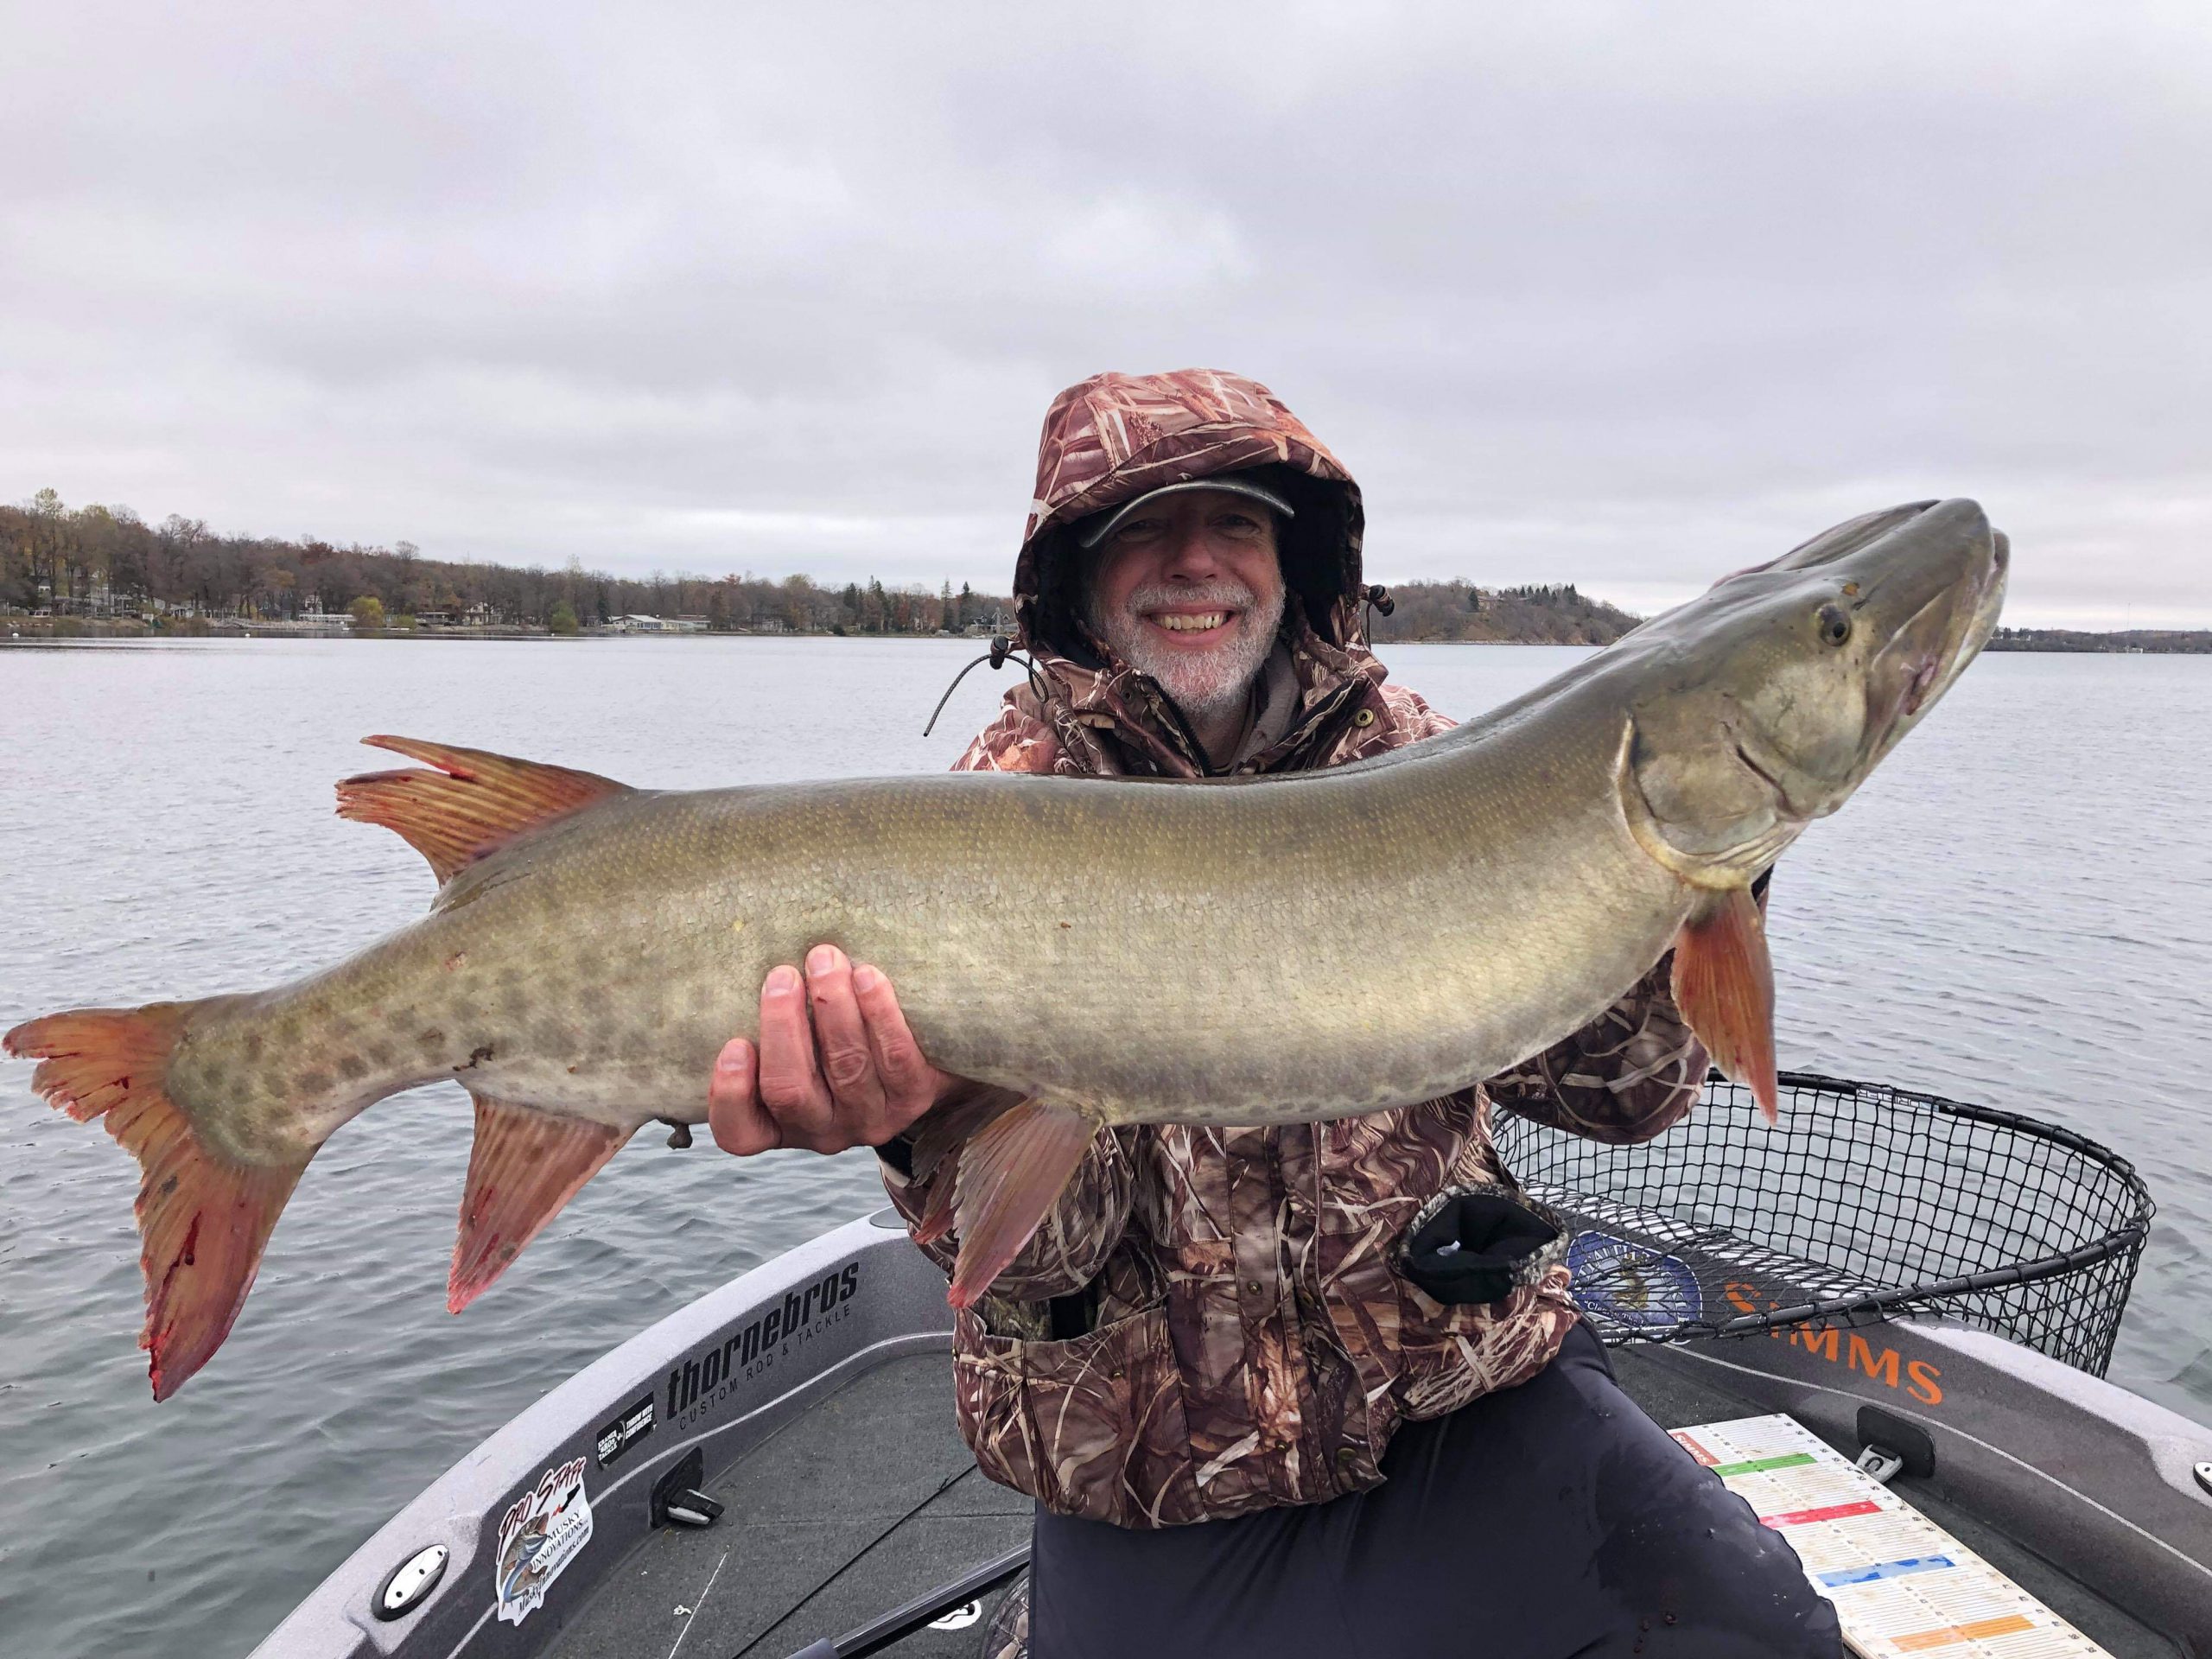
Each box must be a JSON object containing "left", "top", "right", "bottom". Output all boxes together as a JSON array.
[{"left": 445, "top": 1090, "right": 637, "bottom": 1314}]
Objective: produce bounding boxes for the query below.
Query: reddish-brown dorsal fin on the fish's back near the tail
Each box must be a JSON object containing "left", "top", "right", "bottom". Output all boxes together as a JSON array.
[{"left": 339, "top": 736, "right": 637, "bottom": 885}]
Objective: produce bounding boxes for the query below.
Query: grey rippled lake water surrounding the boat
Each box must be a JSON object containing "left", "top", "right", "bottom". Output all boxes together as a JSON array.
[{"left": 0, "top": 639, "right": 2212, "bottom": 1655}]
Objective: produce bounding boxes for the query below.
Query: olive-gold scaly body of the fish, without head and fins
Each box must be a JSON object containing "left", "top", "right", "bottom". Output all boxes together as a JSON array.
[{"left": 186, "top": 699, "right": 1692, "bottom": 1144}]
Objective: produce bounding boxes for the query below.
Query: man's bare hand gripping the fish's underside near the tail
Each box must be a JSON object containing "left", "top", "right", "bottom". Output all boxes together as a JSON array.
[{"left": 708, "top": 944, "right": 960, "bottom": 1157}]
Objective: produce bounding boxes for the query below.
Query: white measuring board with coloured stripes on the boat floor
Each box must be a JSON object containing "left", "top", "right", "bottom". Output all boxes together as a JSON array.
[{"left": 1672, "top": 1415, "right": 2110, "bottom": 1659}]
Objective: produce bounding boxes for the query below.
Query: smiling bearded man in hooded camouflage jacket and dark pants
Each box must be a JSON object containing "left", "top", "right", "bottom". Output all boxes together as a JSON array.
[{"left": 710, "top": 372, "right": 1840, "bottom": 1659}]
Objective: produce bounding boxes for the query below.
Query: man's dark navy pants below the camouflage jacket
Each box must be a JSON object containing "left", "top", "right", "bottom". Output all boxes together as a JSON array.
[{"left": 1028, "top": 1325, "right": 1842, "bottom": 1659}]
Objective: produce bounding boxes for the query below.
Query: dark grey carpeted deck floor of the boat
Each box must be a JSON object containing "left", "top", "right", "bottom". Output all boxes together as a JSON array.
[{"left": 546, "top": 1350, "right": 2183, "bottom": 1659}]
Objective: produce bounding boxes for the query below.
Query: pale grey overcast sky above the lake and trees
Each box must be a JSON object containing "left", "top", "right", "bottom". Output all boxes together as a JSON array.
[{"left": 0, "top": 0, "right": 2212, "bottom": 626}]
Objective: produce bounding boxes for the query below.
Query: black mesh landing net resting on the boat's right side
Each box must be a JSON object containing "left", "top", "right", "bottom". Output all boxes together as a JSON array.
[{"left": 1496, "top": 1073, "right": 2154, "bottom": 1376}]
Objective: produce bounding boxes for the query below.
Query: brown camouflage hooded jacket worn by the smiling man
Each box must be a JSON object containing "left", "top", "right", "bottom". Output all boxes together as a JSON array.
[{"left": 885, "top": 376, "right": 1706, "bottom": 1526}]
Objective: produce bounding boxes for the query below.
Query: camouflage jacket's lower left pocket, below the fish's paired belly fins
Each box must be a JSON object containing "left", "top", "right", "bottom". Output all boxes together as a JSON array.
[{"left": 953, "top": 1303, "right": 1201, "bottom": 1526}]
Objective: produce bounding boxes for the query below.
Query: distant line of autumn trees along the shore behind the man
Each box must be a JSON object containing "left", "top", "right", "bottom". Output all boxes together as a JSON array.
[{"left": 0, "top": 489, "right": 1637, "bottom": 646}]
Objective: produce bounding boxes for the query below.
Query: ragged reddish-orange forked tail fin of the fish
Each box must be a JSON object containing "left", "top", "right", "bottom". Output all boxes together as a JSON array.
[{"left": 0, "top": 1002, "right": 312, "bottom": 1400}]
